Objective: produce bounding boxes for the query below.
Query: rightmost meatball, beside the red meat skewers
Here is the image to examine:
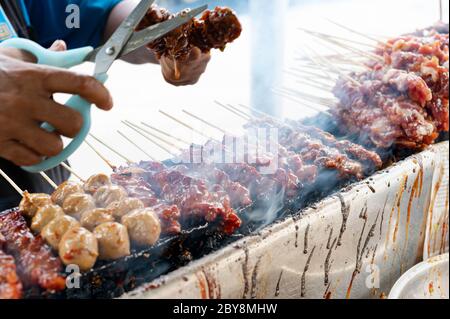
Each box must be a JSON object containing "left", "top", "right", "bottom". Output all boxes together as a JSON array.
[{"left": 122, "top": 208, "right": 161, "bottom": 246}]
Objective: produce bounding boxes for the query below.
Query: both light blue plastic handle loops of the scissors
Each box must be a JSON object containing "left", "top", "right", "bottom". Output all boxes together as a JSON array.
[{"left": 0, "top": 38, "right": 102, "bottom": 173}]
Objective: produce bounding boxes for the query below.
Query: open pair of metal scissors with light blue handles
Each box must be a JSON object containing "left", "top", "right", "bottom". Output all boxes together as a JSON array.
[{"left": 0, "top": 0, "right": 207, "bottom": 173}]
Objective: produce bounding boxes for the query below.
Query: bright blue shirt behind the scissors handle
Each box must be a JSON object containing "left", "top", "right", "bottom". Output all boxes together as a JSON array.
[{"left": 24, "top": 0, "right": 121, "bottom": 49}]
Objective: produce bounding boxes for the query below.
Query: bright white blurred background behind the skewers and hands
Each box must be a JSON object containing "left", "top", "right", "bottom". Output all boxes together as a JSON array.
[{"left": 67, "top": 0, "right": 448, "bottom": 176}]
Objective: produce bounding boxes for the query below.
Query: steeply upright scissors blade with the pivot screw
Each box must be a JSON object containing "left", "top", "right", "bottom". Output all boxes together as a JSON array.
[{"left": 95, "top": 0, "right": 155, "bottom": 75}]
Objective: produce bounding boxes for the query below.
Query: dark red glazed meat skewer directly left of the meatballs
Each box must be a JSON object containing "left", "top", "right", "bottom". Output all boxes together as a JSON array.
[{"left": 0, "top": 212, "right": 66, "bottom": 291}]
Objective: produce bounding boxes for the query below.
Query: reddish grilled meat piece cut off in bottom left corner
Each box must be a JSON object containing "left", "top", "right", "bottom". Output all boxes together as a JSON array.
[{"left": 0, "top": 233, "right": 22, "bottom": 300}]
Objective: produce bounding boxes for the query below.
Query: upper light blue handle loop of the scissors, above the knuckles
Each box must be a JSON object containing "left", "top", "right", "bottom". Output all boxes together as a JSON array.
[{"left": 0, "top": 38, "right": 94, "bottom": 69}]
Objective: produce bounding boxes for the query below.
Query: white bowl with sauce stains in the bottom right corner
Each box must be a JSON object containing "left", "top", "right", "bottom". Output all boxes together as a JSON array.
[{"left": 389, "top": 253, "right": 449, "bottom": 299}]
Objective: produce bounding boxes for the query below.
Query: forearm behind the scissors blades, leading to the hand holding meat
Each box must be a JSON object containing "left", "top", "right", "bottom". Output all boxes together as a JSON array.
[{"left": 104, "top": 0, "right": 159, "bottom": 64}]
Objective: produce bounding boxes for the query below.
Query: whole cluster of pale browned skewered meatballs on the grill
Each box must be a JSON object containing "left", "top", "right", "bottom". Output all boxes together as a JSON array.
[{"left": 12, "top": 174, "right": 165, "bottom": 271}]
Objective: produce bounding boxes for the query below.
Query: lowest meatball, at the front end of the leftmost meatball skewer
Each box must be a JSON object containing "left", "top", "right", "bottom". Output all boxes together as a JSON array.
[{"left": 59, "top": 227, "right": 98, "bottom": 271}]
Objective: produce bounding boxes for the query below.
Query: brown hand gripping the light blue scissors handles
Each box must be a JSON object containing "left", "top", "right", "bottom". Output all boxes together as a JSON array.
[{"left": 0, "top": 44, "right": 113, "bottom": 166}]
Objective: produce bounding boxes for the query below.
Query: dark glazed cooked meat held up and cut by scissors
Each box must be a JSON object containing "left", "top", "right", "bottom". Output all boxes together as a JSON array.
[{"left": 138, "top": 5, "right": 242, "bottom": 60}]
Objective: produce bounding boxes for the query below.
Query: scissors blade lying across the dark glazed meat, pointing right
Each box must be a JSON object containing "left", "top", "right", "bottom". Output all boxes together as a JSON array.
[{"left": 86, "top": 5, "right": 208, "bottom": 62}]
